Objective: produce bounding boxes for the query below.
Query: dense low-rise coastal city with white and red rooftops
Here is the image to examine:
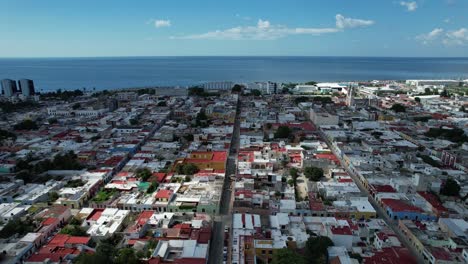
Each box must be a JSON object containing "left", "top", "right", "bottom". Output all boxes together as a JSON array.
[{"left": 0, "top": 79, "right": 468, "bottom": 264}]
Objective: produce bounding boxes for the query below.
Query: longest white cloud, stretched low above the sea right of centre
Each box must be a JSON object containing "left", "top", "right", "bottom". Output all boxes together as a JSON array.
[{"left": 171, "top": 14, "right": 374, "bottom": 40}]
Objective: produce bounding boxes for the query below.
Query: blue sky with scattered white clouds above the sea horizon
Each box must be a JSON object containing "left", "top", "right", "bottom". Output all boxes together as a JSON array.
[{"left": 0, "top": 0, "right": 468, "bottom": 57}]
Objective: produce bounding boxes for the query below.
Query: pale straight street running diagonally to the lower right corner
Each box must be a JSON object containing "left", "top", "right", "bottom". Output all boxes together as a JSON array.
[{"left": 319, "top": 131, "right": 426, "bottom": 263}]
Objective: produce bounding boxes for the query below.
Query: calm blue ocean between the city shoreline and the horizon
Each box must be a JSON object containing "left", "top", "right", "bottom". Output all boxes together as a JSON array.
[{"left": 0, "top": 57, "right": 468, "bottom": 92}]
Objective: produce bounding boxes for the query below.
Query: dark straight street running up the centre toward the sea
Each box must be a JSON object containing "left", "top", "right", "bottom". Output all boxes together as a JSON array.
[{"left": 208, "top": 97, "right": 241, "bottom": 264}]
